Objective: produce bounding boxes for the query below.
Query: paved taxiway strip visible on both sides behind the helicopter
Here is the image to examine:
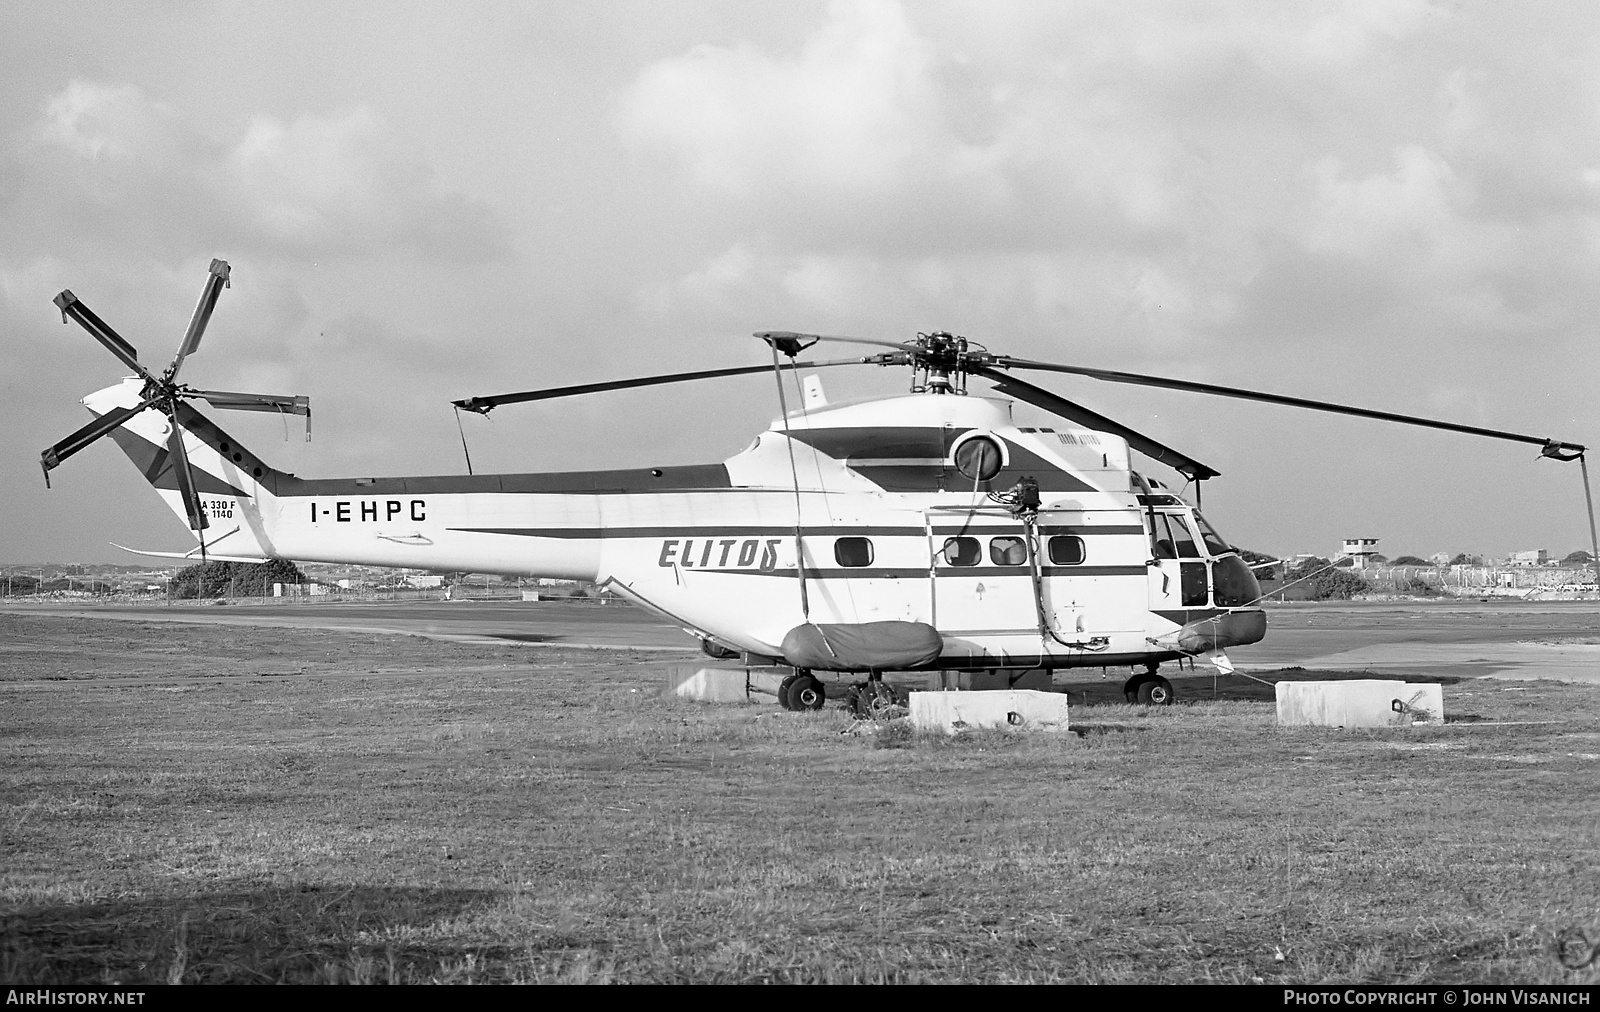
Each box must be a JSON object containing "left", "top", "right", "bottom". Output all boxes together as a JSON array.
[{"left": 3, "top": 600, "right": 1600, "bottom": 682}]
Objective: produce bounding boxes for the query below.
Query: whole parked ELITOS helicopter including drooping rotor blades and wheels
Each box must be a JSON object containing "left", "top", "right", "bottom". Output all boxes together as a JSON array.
[{"left": 40, "top": 259, "right": 1600, "bottom": 709}]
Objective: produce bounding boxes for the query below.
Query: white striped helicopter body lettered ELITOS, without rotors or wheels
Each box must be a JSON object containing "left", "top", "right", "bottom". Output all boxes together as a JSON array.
[{"left": 85, "top": 380, "right": 1264, "bottom": 669}]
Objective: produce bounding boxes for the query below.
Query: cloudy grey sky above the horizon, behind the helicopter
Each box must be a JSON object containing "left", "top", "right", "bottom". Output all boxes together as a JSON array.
[{"left": 0, "top": 0, "right": 1600, "bottom": 562}]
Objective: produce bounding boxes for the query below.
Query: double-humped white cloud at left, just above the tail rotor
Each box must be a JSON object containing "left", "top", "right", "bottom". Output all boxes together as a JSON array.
[{"left": 0, "top": 80, "right": 506, "bottom": 261}]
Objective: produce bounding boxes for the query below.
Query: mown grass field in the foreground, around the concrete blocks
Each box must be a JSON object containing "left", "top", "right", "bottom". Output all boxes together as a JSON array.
[{"left": 0, "top": 615, "right": 1600, "bottom": 983}]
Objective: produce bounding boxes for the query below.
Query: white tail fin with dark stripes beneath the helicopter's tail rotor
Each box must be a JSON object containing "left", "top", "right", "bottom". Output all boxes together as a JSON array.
[{"left": 83, "top": 376, "right": 282, "bottom": 559}]
